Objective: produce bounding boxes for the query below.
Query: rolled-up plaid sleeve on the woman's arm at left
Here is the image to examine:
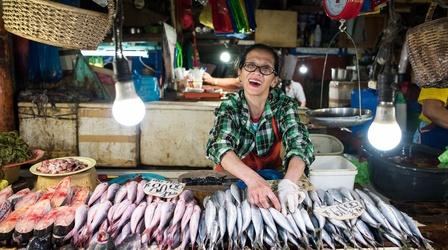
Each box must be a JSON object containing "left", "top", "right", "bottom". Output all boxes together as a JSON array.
[{"left": 206, "top": 105, "right": 238, "bottom": 164}]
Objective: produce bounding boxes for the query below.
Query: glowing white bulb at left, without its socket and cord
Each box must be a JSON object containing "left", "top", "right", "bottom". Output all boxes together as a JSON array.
[{"left": 112, "top": 81, "right": 146, "bottom": 126}]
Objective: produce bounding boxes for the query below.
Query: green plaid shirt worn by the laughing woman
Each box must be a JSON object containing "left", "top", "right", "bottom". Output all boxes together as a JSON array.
[{"left": 206, "top": 88, "right": 314, "bottom": 172}]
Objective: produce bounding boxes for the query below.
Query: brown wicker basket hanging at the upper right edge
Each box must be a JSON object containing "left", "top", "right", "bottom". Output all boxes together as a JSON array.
[{"left": 406, "top": 2, "right": 448, "bottom": 88}]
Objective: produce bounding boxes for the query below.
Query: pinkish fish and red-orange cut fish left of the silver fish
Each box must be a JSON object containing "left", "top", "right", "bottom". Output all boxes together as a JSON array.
[{"left": 0, "top": 177, "right": 201, "bottom": 249}]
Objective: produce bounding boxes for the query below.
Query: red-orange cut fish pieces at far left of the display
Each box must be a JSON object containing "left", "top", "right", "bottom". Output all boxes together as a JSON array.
[{"left": 0, "top": 177, "right": 90, "bottom": 249}]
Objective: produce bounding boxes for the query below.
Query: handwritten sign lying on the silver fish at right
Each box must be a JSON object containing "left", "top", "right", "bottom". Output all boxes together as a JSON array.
[{"left": 314, "top": 201, "right": 364, "bottom": 220}]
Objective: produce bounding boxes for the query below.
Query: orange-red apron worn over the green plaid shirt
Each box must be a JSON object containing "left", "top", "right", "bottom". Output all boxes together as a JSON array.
[{"left": 215, "top": 117, "right": 282, "bottom": 172}]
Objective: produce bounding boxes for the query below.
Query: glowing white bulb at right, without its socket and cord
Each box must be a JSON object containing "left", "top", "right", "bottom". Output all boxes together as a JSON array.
[{"left": 367, "top": 102, "right": 401, "bottom": 151}]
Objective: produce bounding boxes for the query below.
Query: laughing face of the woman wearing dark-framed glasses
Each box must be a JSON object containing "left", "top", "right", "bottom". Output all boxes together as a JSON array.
[{"left": 238, "top": 49, "right": 277, "bottom": 97}]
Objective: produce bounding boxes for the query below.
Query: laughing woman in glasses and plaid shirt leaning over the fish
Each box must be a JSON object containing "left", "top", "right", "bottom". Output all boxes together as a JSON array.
[{"left": 206, "top": 44, "right": 314, "bottom": 213}]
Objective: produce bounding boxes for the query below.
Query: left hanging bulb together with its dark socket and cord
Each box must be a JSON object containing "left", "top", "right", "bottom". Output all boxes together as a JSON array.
[{"left": 112, "top": 0, "right": 146, "bottom": 126}]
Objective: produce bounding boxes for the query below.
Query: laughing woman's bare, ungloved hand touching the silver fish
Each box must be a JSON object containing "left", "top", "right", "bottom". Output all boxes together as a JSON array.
[{"left": 246, "top": 177, "right": 281, "bottom": 211}]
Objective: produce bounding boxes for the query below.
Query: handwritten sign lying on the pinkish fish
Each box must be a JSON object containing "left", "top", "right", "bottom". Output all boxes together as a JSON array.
[{"left": 143, "top": 180, "right": 185, "bottom": 199}]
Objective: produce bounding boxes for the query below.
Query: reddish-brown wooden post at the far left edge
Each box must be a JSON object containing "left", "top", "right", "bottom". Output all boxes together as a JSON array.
[{"left": 0, "top": 5, "right": 15, "bottom": 132}]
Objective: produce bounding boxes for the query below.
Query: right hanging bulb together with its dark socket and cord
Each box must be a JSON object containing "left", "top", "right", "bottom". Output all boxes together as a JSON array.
[{"left": 367, "top": 65, "right": 402, "bottom": 151}]
